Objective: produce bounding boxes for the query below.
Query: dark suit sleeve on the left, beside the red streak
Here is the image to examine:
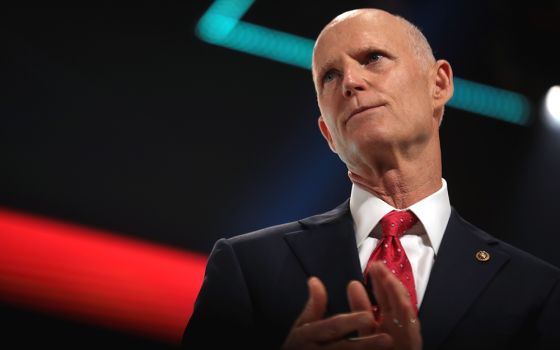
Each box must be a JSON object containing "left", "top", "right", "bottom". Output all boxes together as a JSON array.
[{"left": 182, "top": 239, "right": 255, "bottom": 349}]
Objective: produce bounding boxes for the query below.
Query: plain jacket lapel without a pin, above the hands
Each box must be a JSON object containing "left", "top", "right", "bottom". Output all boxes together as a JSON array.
[{"left": 286, "top": 201, "right": 362, "bottom": 315}]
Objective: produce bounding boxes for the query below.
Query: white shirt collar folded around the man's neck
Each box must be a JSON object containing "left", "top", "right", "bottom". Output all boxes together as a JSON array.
[{"left": 350, "top": 179, "right": 451, "bottom": 254}]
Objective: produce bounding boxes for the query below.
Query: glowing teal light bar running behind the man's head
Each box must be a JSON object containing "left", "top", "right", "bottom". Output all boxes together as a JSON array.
[{"left": 196, "top": 0, "right": 531, "bottom": 125}]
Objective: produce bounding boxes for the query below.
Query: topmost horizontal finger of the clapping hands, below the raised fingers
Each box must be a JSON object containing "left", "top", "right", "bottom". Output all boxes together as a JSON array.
[{"left": 298, "top": 311, "right": 373, "bottom": 343}]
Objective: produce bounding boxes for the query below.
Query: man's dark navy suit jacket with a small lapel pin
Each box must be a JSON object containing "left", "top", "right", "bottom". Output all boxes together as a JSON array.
[{"left": 183, "top": 201, "right": 560, "bottom": 349}]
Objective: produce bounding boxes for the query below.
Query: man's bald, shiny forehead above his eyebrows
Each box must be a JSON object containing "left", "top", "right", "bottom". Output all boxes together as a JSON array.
[{"left": 313, "top": 12, "right": 407, "bottom": 72}]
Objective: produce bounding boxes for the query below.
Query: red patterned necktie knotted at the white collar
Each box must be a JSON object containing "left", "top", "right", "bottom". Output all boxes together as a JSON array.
[{"left": 364, "top": 210, "right": 418, "bottom": 313}]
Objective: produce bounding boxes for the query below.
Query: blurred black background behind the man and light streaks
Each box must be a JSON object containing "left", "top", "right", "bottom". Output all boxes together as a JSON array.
[{"left": 0, "top": 0, "right": 560, "bottom": 348}]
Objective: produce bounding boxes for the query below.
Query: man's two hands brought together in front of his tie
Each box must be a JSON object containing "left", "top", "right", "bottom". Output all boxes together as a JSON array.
[{"left": 282, "top": 264, "right": 422, "bottom": 350}]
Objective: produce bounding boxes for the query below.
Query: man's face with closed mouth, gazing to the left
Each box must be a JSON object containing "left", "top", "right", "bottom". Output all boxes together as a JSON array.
[{"left": 313, "top": 11, "right": 439, "bottom": 170}]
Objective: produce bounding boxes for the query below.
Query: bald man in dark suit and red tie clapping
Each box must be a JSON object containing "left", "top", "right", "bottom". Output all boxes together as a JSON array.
[{"left": 184, "top": 9, "right": 560, "bottom": 349}]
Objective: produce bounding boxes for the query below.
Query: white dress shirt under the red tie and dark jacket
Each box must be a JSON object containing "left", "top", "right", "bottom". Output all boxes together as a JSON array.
[{"left": 350, "top": 179, "right": 451, "bottom": 308}]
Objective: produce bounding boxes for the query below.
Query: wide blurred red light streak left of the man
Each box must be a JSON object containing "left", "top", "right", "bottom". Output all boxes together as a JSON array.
[{"left": 0, "top": 209, "right": 207, "bottom": 344}]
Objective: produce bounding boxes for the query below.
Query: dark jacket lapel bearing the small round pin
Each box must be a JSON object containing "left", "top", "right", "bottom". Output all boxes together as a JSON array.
[{"left": 419, "top": 210, "right": 509, "bottom": 349}]
